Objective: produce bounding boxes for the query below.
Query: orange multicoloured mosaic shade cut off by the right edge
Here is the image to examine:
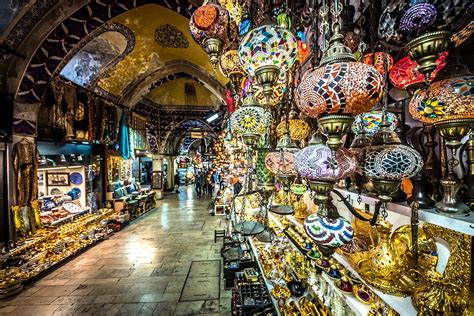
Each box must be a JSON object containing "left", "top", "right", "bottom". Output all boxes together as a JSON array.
[{"left": 409, "top": 76, "right": 474, "bottom": 123}]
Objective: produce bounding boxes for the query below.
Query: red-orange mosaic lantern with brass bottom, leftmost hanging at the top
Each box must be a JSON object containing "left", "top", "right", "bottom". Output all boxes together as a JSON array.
[{"left": 189, "top": 3, "right": 237, "bottom": 67}]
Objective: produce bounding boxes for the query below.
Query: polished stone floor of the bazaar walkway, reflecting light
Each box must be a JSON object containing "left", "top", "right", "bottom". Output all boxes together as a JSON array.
[{"left": 0, "top": 186, "right": 231, "bottom": 316}]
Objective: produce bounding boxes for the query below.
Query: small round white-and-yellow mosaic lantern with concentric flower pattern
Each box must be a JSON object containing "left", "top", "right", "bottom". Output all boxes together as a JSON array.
[{"left": 230, "top": 87, "right": 271, "bottom": 145}]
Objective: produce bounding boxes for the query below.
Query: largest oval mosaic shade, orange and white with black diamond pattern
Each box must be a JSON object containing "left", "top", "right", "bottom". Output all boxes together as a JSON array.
[{"left": 296, "top": 62, "right": 383, "bottom": 118}]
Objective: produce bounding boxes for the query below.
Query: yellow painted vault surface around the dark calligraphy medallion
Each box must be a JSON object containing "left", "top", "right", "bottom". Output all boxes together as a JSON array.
[{"left": 98, "top": 4, "right": 227, "bottom": 96}]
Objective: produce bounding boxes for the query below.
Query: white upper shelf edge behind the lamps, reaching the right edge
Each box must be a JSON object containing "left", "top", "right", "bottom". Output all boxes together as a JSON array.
[{"left": 334, "top": 188, "right": 474, "bottom": 236}]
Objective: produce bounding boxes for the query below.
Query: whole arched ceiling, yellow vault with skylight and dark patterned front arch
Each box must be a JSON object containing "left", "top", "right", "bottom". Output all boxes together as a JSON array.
[{"left": 6, "top": 0, "right": 227, "bottom": 106}]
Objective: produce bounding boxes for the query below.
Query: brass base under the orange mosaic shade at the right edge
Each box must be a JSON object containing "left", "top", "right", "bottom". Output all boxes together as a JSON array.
[{"left": 433, "top": 118, "right": 474, "bottom": 149}]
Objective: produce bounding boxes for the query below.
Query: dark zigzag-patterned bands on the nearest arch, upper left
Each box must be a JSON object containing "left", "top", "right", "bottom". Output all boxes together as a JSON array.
[{"left": 12, "top": 0, "right": 196, "bottom": 103}]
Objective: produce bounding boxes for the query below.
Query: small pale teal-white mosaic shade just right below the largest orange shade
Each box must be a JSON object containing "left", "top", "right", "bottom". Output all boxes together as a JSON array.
[{"left": 352, "top": 110, "right": 398, "bottom": 136}]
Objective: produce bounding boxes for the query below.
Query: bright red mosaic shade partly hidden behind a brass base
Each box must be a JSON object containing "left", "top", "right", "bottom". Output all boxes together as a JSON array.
[{"left": 389, "top": 52, "right": 448, "bottom": 89}]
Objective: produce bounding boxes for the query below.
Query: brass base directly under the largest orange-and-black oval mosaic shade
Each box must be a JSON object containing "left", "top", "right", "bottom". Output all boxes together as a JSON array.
[{"left": 318, "top": 115, "right": 354, "bottom": 151}]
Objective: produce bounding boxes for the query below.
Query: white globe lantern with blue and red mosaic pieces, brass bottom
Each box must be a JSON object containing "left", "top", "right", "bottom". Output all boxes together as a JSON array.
[{"left": 239, "top": 24, "right": 298, "bottom": 99}]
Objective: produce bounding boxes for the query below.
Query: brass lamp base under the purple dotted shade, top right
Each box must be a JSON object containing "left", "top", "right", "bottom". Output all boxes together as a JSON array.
[{"left": 405, "top": 31, "right": 451, "bottom": 79}]
